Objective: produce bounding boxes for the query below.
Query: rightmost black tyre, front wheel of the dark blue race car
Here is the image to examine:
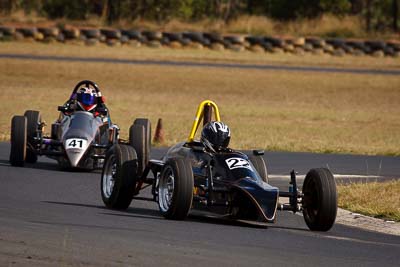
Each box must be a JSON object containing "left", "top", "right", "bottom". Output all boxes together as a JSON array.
[{"left": 302, "top": 168, "right": 337, "bottom": 231}]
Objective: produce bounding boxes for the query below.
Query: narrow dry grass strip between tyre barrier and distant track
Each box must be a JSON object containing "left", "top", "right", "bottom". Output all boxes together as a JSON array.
[{"left": 0, "top": 41, "right": 400, "bottom": 70}]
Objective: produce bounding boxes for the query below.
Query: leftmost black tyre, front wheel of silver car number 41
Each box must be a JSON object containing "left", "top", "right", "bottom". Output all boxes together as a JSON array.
[{"left": 10, "top": 116, "right": 27, "bottom": 167}]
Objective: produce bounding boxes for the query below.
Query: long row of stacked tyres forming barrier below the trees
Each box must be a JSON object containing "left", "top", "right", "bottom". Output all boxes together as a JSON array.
[{"left": 0, "top": 26, "right": 400, "bottom": 57}]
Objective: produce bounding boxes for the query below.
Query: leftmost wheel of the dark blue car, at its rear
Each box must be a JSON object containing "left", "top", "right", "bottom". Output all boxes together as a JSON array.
[{"left": 100, "top": 144, "right": 137, "bottom": 210}]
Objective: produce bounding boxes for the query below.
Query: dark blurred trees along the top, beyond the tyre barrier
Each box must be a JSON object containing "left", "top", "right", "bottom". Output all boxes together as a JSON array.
[{"left": 0, "top": 0, "right": 400, "bottom": 31}]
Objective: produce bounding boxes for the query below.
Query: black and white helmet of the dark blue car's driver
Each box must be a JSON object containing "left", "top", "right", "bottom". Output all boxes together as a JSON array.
[{"left": 200, "top": 121, "right": 231, "bottom": 150}]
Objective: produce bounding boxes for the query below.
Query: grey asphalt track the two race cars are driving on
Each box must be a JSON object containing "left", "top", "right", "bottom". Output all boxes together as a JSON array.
[{"left": 0, "top": 143, "right": 400, "bottom": 267}]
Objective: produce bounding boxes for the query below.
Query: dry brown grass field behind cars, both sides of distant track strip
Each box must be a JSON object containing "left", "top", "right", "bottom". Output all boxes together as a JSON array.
[{"left": 0, "top": 43, "right": 400, "bottom": 155}]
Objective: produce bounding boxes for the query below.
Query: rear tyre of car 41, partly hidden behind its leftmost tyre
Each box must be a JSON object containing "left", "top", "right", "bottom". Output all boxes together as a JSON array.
[{"left": 24, "top": 110, "right": 42, "bottom": 163}]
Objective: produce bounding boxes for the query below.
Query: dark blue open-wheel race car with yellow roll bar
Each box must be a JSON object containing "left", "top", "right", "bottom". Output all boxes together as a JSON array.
[{"left": 101, "top": 100, "right": 337, "bottom": 231}]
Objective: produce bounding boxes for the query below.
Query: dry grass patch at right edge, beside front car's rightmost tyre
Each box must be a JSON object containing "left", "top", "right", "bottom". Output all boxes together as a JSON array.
[{"left": 338, "top": 180, "right": 400, "bottom": 222}]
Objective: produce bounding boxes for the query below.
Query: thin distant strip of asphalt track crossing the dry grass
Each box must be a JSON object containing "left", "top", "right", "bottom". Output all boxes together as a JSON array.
[{"left": 0, "top": 54, "right": 400, "bottom": 75}]
